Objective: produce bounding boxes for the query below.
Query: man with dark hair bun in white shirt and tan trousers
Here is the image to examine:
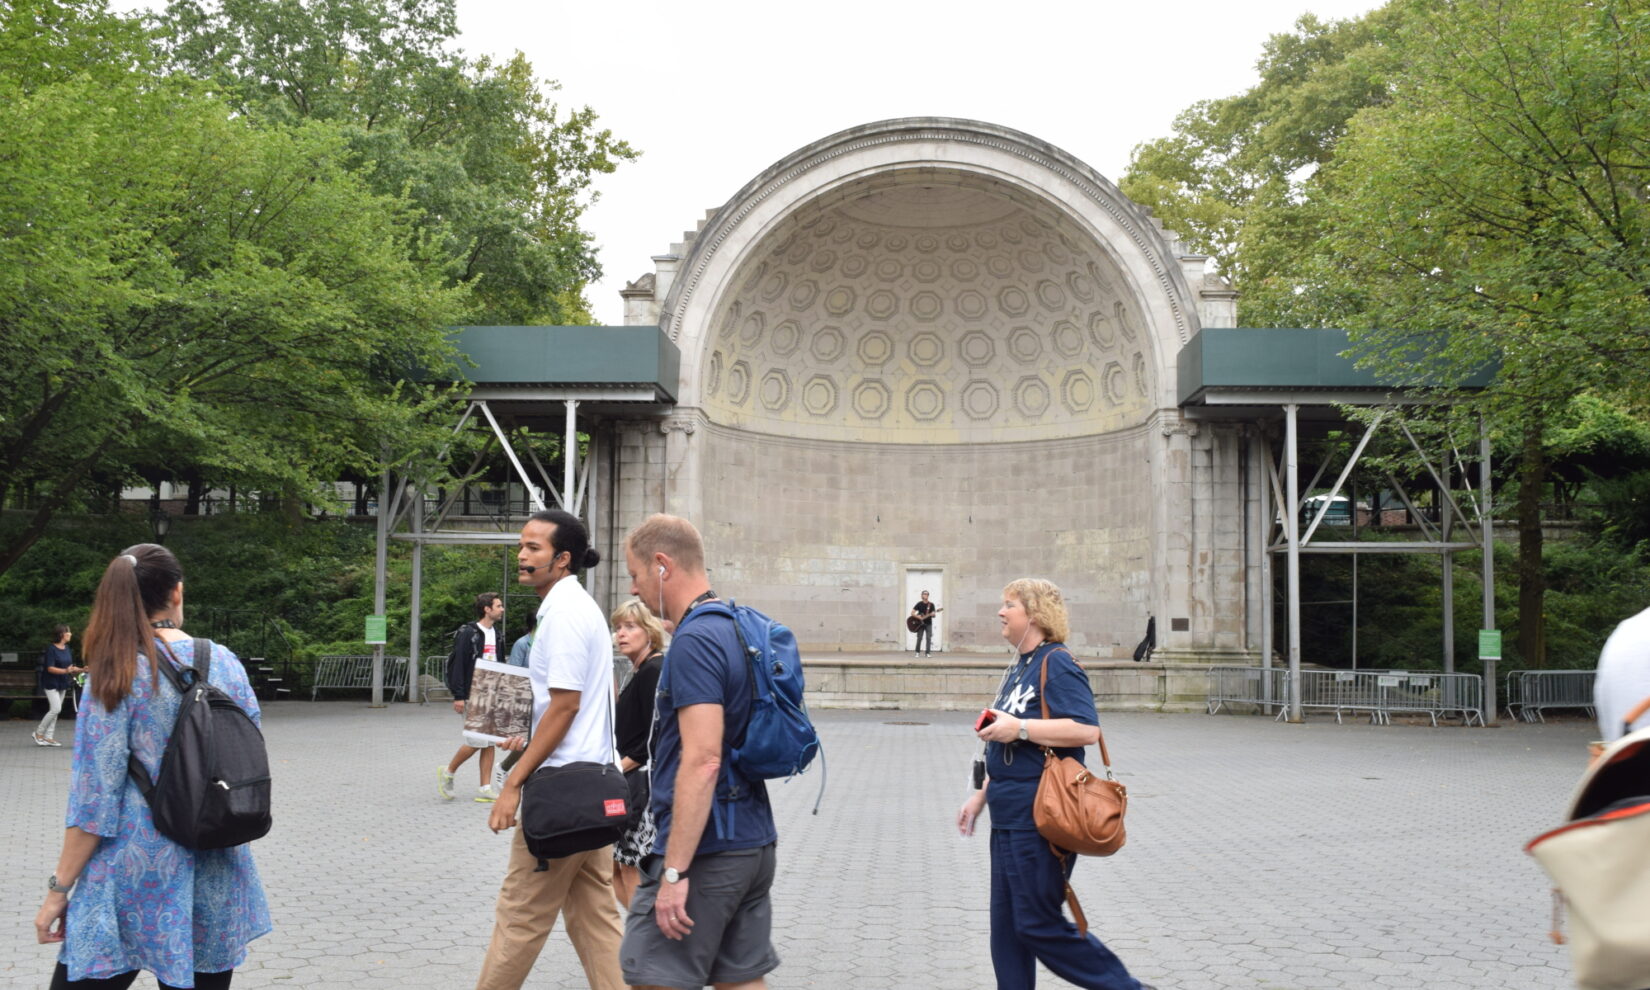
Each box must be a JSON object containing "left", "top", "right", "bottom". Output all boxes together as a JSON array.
[{"left": 475, "top": 510, "right": 625, "bottom": 990}]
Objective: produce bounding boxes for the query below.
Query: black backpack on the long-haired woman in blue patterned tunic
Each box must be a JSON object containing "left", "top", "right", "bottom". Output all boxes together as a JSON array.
[{"left": 125, "top": 639, "right": 272, "bottom": 850}]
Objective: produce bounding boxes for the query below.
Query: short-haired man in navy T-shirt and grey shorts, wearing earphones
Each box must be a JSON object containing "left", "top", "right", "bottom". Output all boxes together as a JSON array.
[{"left": 619, "top": 515, "right": 779, "bottom": 990}]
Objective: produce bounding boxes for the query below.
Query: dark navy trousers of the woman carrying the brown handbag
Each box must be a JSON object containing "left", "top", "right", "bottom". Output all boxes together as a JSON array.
[{"left": 992, "top": 828, "right": 1140, "bottom": 990}]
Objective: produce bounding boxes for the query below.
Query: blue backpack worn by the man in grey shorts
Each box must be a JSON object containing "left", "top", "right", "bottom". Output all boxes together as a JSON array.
[{"left": 676, "top": 601, "right": 825, "bottom": 828}]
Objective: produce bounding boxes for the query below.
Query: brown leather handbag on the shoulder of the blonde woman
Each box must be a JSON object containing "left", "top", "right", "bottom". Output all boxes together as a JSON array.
[{"left": 1031, "top": 650, "right": 1129, "bottom": 934}]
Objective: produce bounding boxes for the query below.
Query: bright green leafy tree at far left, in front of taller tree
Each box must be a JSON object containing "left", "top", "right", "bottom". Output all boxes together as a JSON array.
[{"left": 0, "top": 3, "right": 467, "bottom": 573}]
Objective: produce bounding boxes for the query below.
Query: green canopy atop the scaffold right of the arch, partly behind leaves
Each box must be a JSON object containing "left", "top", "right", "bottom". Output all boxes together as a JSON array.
[{"left": 1176, "top": 327, "right": 1495, "bottom": 406}]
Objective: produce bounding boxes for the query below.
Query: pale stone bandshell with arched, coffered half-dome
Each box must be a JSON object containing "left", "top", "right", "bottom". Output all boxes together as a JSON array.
[{"left": 597, "top": 119, "right": 1259, "bottom": 660}]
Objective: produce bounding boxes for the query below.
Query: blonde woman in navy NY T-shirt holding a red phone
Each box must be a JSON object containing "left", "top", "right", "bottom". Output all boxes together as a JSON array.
[{"left": 957, "top": 578, "right": 1152, "bottom": 990}]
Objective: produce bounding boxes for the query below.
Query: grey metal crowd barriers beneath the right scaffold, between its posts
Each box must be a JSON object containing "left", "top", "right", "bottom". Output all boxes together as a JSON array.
[{"left": 1206, "top": 667, "right": 1483, "bottom": 726}]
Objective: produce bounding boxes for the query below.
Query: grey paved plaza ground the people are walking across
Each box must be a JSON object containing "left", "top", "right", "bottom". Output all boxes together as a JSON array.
[{"left": 0, "top": 701, "right": 1592, "bottom": 990}]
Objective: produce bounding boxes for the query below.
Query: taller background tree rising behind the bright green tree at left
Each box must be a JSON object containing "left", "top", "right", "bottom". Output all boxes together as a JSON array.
[{"left": 157, "top": 0, "right": 635, "bottom": 323}]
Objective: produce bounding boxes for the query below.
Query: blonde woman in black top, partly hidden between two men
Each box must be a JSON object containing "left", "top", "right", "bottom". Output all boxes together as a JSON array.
[{"left": 609, "top": 599, "right": 665, "bottom": 908}]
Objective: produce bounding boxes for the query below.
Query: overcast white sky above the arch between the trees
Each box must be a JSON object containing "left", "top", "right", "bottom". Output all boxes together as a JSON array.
[{"left": 116, "top": 0, "right": 1379, "bottom": 323}]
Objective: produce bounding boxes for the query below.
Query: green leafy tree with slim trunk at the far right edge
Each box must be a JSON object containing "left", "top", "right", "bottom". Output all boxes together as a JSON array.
[{"left": 1312, "top": 0, "right": 1650, "bottom": 663}]
